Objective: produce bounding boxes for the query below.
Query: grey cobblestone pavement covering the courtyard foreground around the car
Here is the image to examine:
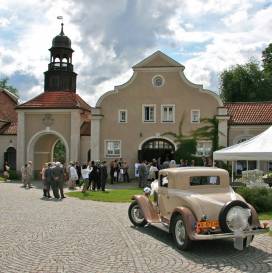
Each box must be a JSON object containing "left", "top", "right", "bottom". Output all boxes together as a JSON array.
[{"left": 0, "top": 183, "right": 272, "bottom": 273}]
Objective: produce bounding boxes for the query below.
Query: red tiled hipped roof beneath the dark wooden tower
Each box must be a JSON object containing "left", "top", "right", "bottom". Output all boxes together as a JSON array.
[{"left": 16, "top": 91, "right": 91, "bottom": 111}]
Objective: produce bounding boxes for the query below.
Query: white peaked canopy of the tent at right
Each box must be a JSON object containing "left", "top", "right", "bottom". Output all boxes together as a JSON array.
[{"left": 213, "top": 126, "right": 272, "bottom": 161}]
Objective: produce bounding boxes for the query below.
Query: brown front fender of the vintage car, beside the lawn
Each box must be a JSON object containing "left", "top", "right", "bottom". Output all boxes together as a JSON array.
[{"left": 132, "top": 195, "right": 161, "bottom": 223}]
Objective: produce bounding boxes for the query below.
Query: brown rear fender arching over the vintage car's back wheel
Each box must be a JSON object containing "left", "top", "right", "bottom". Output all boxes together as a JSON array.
[{"left": 170, "top": 207, "right": 196, "bottom": 240}]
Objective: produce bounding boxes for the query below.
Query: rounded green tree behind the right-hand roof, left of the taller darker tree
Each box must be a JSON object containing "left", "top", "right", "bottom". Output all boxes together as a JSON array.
[{"left": 220, "top": 61, "right": 266, "bottom": 102}]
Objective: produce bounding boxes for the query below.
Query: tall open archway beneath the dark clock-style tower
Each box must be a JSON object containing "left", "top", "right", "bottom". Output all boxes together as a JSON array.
[{"left": 27, "top": 131, "right": 69, "bottom": 174}]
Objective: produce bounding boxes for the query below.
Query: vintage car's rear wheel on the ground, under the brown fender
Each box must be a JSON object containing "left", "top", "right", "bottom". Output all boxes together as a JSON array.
[{"left": 172, "top": 214, "right": 192, "bottom": 250}]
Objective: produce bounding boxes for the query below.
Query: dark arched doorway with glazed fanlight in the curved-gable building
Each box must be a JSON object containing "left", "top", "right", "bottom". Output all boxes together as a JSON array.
[{"left": 138, "top": 138, "right": 175, "bottom": 162}]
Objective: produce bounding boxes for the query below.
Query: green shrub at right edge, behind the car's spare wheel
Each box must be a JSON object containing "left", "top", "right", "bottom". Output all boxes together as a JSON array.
[{"left": 236, "top": 187, "right": 272, "bottom": 212}]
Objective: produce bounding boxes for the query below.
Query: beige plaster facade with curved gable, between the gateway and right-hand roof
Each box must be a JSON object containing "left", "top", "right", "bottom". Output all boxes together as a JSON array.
[{"left": 96, "top": 55, "right": 220, "bottom": 172}]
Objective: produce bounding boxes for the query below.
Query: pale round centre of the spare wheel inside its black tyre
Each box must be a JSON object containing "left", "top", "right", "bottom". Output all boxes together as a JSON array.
[{"left": 226, "top": 206, "right": 251, "bottom": 232}]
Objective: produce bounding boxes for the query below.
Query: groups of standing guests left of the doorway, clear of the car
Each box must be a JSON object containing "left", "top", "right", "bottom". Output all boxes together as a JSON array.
[{"left": 16, "top": 158, "right": 129, "bottom": 199}]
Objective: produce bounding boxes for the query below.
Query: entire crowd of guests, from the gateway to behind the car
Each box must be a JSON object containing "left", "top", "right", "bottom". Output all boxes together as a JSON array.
[{"left": 14, "top": 157, "right": 215, "bottom": 199}]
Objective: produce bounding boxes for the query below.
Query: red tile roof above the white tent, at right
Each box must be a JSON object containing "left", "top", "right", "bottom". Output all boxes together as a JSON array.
[{"left": 225, "top": 102, "right": 272, "bottom": 125}]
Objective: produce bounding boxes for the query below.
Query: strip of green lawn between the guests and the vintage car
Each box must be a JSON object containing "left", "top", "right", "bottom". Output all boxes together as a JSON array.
[{"left": 66, "top": 189, "right": 143, "bottom": 203}]
